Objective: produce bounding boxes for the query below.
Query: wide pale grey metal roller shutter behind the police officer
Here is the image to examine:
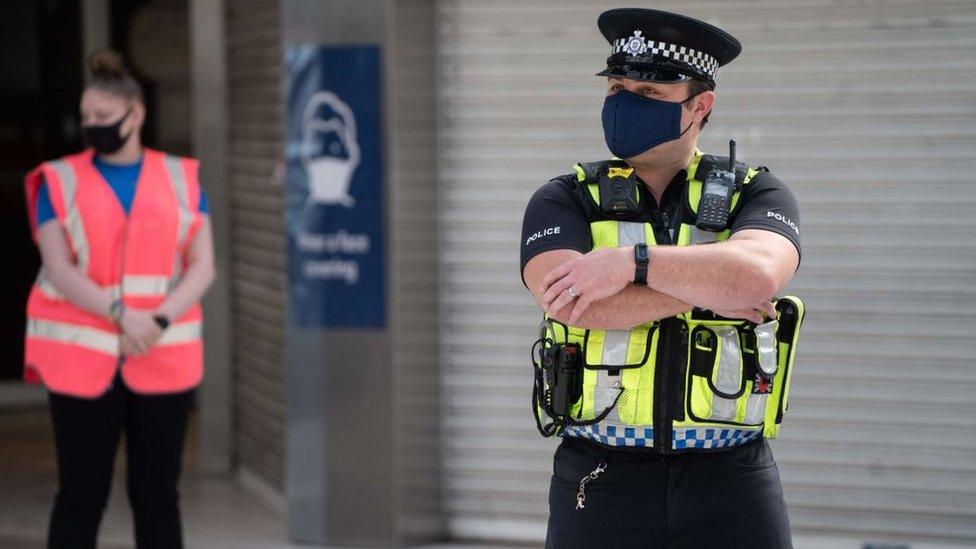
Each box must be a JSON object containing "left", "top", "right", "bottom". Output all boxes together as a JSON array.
[{"left": 438, "top": 0, "right": 976, "bottom": 542}]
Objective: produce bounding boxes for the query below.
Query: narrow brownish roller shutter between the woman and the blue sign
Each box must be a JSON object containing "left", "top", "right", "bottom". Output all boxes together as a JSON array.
[{"left": 225, "top": 0, "right": 285, "bottom": 492}]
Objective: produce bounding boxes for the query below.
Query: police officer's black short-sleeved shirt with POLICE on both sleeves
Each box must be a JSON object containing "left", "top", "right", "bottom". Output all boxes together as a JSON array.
[{"left": 521, "top": 166, "right": 800, "bottom": 284}]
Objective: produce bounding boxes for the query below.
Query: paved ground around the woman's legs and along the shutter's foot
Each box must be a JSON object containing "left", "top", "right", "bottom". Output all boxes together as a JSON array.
[{"left": 0, "top": 400, "right": 958, "bottom": 549}]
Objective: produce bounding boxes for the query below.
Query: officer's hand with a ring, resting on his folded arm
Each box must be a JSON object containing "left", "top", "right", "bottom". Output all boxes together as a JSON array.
[{"left": 542, "top": 246, "right": 636, "bottom": 324}]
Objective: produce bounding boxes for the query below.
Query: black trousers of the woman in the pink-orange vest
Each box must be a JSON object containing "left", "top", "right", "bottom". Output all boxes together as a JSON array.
[{"left": 48, "top": 368, "right": 194, "bottom": 549}]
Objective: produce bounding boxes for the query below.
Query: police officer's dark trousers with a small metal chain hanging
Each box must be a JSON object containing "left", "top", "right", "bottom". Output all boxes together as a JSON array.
[{"left": 546, "top": 437, "right": 793, "bottom": 549}]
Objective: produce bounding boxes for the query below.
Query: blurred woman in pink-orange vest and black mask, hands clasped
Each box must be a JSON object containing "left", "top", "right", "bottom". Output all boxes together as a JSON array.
[{"left": 24, "top": 51, "right": 214, "bottom": 549}]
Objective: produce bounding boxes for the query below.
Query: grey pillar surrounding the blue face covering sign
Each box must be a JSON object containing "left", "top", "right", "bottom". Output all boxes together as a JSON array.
[{"left": 282, "top": 0, "right": 442, "bottom": 547}]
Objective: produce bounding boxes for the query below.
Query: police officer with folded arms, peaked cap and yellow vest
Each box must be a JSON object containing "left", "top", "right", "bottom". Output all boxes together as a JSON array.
[{"left": 521, "top": 9, "right": 802, "bottom": 549}]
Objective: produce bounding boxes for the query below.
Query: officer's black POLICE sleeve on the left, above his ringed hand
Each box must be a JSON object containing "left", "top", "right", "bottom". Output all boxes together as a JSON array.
[{"left": 520, "top": 178, "right": 593, "bottom": 284}]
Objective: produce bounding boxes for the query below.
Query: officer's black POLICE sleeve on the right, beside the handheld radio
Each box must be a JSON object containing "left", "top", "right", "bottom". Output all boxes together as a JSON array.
[{"left": 731, "top": 172, "right": 803, "bottom": 268}]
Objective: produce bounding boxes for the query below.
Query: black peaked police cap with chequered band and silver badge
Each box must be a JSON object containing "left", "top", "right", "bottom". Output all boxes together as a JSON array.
[{"left": 597, "top": 8, "right": 742, "bottom": 87}]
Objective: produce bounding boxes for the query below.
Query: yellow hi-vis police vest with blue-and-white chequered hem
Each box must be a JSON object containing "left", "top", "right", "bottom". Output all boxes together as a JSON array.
[{"left": 534, "top": 150, "right": 804, "bottom": 452}]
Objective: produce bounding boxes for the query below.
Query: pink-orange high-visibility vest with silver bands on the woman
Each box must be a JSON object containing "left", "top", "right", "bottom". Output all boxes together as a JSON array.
[{"left": 24, "top": 148, "right": 203, "bottom": 398}]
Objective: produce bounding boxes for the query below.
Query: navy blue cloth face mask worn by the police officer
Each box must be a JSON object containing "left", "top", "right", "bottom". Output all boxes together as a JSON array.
[{"left": 603, "top": 90, "right": 694, "bottom": 158}]
